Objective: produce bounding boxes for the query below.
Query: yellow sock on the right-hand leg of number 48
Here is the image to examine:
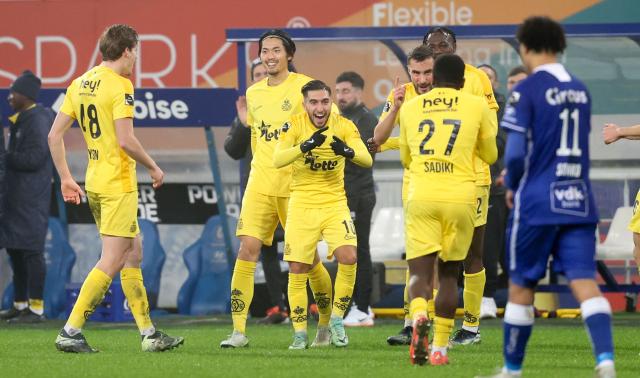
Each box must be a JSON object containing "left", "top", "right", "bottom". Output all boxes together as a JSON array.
[{"left": 120, "top": 268, "right": 155, "bottom": 336}]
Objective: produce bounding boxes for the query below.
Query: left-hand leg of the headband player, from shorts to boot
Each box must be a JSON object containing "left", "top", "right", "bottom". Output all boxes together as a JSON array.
[{"left": 220, "top": 191, "right": 278, "bottom": 348}]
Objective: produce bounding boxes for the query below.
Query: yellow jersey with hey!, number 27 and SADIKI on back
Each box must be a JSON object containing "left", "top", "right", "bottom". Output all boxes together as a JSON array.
[{"left": 400, "top": 88, "right": 497, "bottom": 204}]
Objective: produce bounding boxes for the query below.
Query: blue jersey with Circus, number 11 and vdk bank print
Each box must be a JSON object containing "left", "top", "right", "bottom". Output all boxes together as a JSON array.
[{"left": 501, "top": 63, "right": 598, "bottom": 225}]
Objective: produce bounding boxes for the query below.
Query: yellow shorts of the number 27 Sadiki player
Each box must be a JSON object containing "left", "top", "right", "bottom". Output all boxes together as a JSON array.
[{"left": 404, "top": 200, "right": 476, "bottom": 261}]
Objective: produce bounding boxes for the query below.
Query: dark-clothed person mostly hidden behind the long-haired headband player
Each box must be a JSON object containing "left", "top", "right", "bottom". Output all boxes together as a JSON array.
[{"left": 224, "top": 59, "right": 289, "bottom": 324}]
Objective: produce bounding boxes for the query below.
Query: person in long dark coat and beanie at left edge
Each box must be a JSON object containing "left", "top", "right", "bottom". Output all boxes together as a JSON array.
[{"left": 0, "top": 71, "right": 55, "bottom": 323}]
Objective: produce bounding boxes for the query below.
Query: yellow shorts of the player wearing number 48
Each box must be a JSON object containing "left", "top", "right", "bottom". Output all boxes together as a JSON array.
[{"left": 87, "top": 191, "right": 140, "bottom": 238}]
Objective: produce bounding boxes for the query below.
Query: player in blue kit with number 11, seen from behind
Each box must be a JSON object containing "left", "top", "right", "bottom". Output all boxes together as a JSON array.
[{"left": 490, "top": 17, "right": 615, "bottom": 377}]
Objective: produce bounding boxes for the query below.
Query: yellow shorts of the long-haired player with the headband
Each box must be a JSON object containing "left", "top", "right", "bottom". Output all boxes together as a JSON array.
[{"left": 236, "top": 192, "right": 289, "bottom": 245}]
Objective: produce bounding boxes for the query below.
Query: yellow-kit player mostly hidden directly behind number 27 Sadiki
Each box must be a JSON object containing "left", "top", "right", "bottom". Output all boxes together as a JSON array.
[{"left": 423, "top": 27, "right": 498, "bottom": 345}]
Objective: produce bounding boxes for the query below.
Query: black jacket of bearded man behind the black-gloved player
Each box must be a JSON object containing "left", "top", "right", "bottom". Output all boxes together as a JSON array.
[{"left": 342, "top": 104, "right": 378, "bottom": 197}]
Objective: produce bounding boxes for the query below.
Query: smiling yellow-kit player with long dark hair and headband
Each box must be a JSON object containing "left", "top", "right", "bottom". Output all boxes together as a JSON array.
[{"left": 220, "top": 29, "right": 331, "bottom": 348}]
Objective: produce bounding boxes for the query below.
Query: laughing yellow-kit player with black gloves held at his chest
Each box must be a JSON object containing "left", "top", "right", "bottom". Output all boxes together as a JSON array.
[{"left": 273, "top": 80, "right": 373, "bottom": 349}]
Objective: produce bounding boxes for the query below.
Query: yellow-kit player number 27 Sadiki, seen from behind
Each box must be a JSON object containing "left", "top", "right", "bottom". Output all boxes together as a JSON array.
[{"left": 400, "top": 55, "right": 498, "bottom": 365}]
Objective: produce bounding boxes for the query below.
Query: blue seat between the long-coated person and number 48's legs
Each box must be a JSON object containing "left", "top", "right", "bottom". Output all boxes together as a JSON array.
[{"left": 2, "top": 218, "right": 76, "bottom": 319}]
